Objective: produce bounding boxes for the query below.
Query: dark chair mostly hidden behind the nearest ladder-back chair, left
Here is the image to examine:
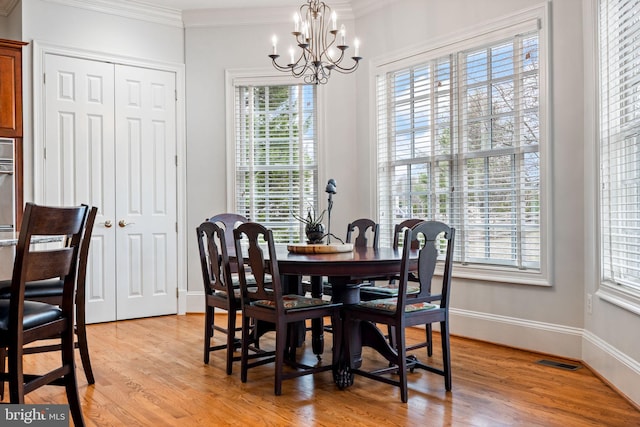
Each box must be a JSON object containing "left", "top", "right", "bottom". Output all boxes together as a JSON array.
[{"left": 0, "top": 206, "right": 98, "bottom": 388}]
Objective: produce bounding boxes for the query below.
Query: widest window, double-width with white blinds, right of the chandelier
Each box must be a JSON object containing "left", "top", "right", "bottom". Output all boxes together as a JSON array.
[{"left": 376, "top": 11, "right": 546, "bottom": 284}]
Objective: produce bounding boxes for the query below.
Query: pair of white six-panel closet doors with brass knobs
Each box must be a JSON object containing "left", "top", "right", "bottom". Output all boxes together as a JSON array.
[{"left": 42, "top": 54, "right": 177, "bottom": 323}]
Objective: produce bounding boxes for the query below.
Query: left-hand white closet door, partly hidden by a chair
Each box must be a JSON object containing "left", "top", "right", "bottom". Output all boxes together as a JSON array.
[{"left": 43, "top": 54, "right": 116, "bottom": 323}]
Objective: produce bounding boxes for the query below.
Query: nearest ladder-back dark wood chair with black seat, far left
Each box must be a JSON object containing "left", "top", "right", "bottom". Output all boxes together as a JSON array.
[{"left": 0, "top": 203, "right": 88, "bottom": 426}]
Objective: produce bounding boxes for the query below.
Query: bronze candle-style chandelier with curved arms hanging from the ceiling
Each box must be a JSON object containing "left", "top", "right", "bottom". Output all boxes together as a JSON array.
[{"left": 269, "top": 0, "right": 362, "bottom": 84}]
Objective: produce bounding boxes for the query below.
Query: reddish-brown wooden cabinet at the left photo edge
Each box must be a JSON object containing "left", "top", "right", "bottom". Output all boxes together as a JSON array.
[{"left": 0, "top": 39, "right": 27, "bottom": 227}]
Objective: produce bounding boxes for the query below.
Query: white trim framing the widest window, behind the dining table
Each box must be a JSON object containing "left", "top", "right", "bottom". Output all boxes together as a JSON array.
[{"left": 369, "top": 2, "right": 554, "bottom": 286}]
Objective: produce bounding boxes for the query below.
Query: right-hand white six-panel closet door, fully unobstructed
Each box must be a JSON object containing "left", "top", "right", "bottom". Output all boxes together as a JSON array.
[{"left": 116, "top": 66, "right": 177, "bottom": 319}]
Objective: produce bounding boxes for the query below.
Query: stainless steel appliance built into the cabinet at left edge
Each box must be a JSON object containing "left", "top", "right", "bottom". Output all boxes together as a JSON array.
[{"left": 0, "top": 138, "right": 16, "bottom": 280}]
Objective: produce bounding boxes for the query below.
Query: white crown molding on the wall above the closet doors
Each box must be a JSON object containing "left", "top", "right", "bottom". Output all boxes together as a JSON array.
[{"left": 41, "top": 0, "right": 184, "bottom": 28}]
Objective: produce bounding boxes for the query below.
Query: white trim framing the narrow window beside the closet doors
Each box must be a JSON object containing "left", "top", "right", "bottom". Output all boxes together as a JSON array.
[{"left": 225, "top": 68, "right": 327, "bottom": 221}]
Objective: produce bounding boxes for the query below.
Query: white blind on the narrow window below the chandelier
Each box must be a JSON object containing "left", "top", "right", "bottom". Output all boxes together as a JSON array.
[{"left": 235, "top": 85, "right": 318, "bottom": 242}]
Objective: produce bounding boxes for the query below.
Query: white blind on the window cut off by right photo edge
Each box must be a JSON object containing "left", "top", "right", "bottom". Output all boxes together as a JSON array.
[{"left": 599, "top": 0, "right": 640, "bottom": 295}]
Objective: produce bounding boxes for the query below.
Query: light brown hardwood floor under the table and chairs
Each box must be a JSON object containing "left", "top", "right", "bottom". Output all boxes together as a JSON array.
[{"left": 16, "top": 314, "right": 640, "bottom": 427}]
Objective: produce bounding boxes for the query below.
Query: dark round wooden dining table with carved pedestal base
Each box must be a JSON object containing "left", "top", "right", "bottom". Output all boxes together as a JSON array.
[{"left": 276, "top": 245, "right": 418, "bottom": 388}]
